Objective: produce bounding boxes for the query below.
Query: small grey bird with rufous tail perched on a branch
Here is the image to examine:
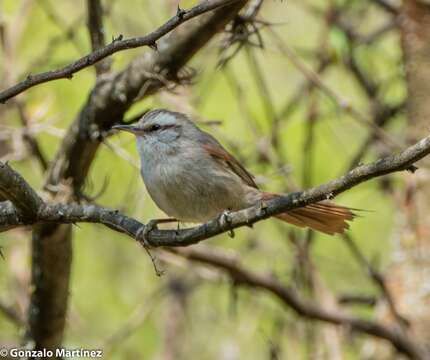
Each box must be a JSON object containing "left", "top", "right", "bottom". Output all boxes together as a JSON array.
[{"left": 113, "top": 109, "right": 355, "bottom": 235}]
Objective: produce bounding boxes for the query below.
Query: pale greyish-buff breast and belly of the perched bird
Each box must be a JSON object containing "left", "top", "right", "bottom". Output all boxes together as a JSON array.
[{"left": 142, "top": 157, "right": 258, "bottom": 222}]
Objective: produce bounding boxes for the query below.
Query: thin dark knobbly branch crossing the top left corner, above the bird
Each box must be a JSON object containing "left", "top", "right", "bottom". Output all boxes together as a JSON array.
[{"left": 0, "top": 0, "right": 241, "bottom": 103}]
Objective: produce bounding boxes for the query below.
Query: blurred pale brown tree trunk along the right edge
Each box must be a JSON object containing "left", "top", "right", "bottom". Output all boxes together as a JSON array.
[{"left": 387, "top": 0, "right": 430, "bottom": 344}]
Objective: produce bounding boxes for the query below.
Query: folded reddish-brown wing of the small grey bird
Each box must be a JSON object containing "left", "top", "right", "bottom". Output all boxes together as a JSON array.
[{"left": 202, "top": 133, "right": 258, "bottom": 189}]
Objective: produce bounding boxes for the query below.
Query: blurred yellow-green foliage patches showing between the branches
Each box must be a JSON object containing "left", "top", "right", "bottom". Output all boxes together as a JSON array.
[{"left": 0, "top": 0, "right": 405, "bottom": 360}]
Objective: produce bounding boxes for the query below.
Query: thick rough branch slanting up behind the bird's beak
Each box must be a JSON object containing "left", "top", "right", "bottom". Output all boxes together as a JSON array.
[{"left": 46, "top": 0, "right": 247, "bottom": 194}]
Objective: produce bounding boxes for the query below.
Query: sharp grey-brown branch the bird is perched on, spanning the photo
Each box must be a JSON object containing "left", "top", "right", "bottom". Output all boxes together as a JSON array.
[{"left": 0, "top": 136, "right": 430, "bottom": 247}]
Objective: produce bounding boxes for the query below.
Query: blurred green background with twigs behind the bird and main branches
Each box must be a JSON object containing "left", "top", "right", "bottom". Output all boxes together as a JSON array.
[{"left": 0, "top": 0, "right": 430, "bottom": 360}]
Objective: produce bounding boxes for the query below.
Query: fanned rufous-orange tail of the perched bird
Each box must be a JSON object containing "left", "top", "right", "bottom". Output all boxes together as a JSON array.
[{"left": 264, "top": 193, "right": 356, "bottom": 235}]
